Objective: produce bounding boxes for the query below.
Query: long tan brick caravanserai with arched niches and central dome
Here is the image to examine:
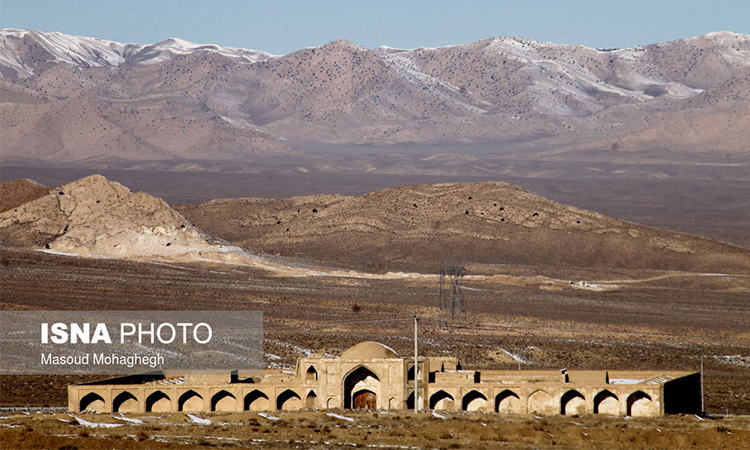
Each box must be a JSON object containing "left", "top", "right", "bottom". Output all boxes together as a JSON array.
[{"left": 68, "top": 342, "right": 701, "bottom": 417}]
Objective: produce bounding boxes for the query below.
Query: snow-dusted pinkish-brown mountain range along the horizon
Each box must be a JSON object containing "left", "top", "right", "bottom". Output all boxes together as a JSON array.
[{"left": 0, "top": 29, "right": 750, "bottom": 165}]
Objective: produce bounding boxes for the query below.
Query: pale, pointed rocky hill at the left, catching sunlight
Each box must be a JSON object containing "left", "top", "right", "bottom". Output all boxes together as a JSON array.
[{"left": 0, "top": 175, "right": 241, "bottom": 260}]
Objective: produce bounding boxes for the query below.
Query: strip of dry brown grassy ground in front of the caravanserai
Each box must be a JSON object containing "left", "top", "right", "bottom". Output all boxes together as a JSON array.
[{"left": 0, "top": 411, "right": 750, "bottom": 450}]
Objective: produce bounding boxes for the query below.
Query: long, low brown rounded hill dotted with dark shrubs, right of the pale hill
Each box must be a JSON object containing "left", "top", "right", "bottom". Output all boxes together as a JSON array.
[{"left": 177, "top": 182, "right": 750, "bottom": 274}]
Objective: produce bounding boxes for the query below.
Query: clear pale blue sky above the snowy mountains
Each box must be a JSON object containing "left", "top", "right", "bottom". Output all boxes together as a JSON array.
[{"left": 0, "top": 0, "right": 750, "bottom": 54}]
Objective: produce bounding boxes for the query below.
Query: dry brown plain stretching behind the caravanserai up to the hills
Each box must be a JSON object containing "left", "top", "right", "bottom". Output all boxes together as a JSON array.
[{"left": 0, "top": 249, "right": 750, "bottom": 414}]
